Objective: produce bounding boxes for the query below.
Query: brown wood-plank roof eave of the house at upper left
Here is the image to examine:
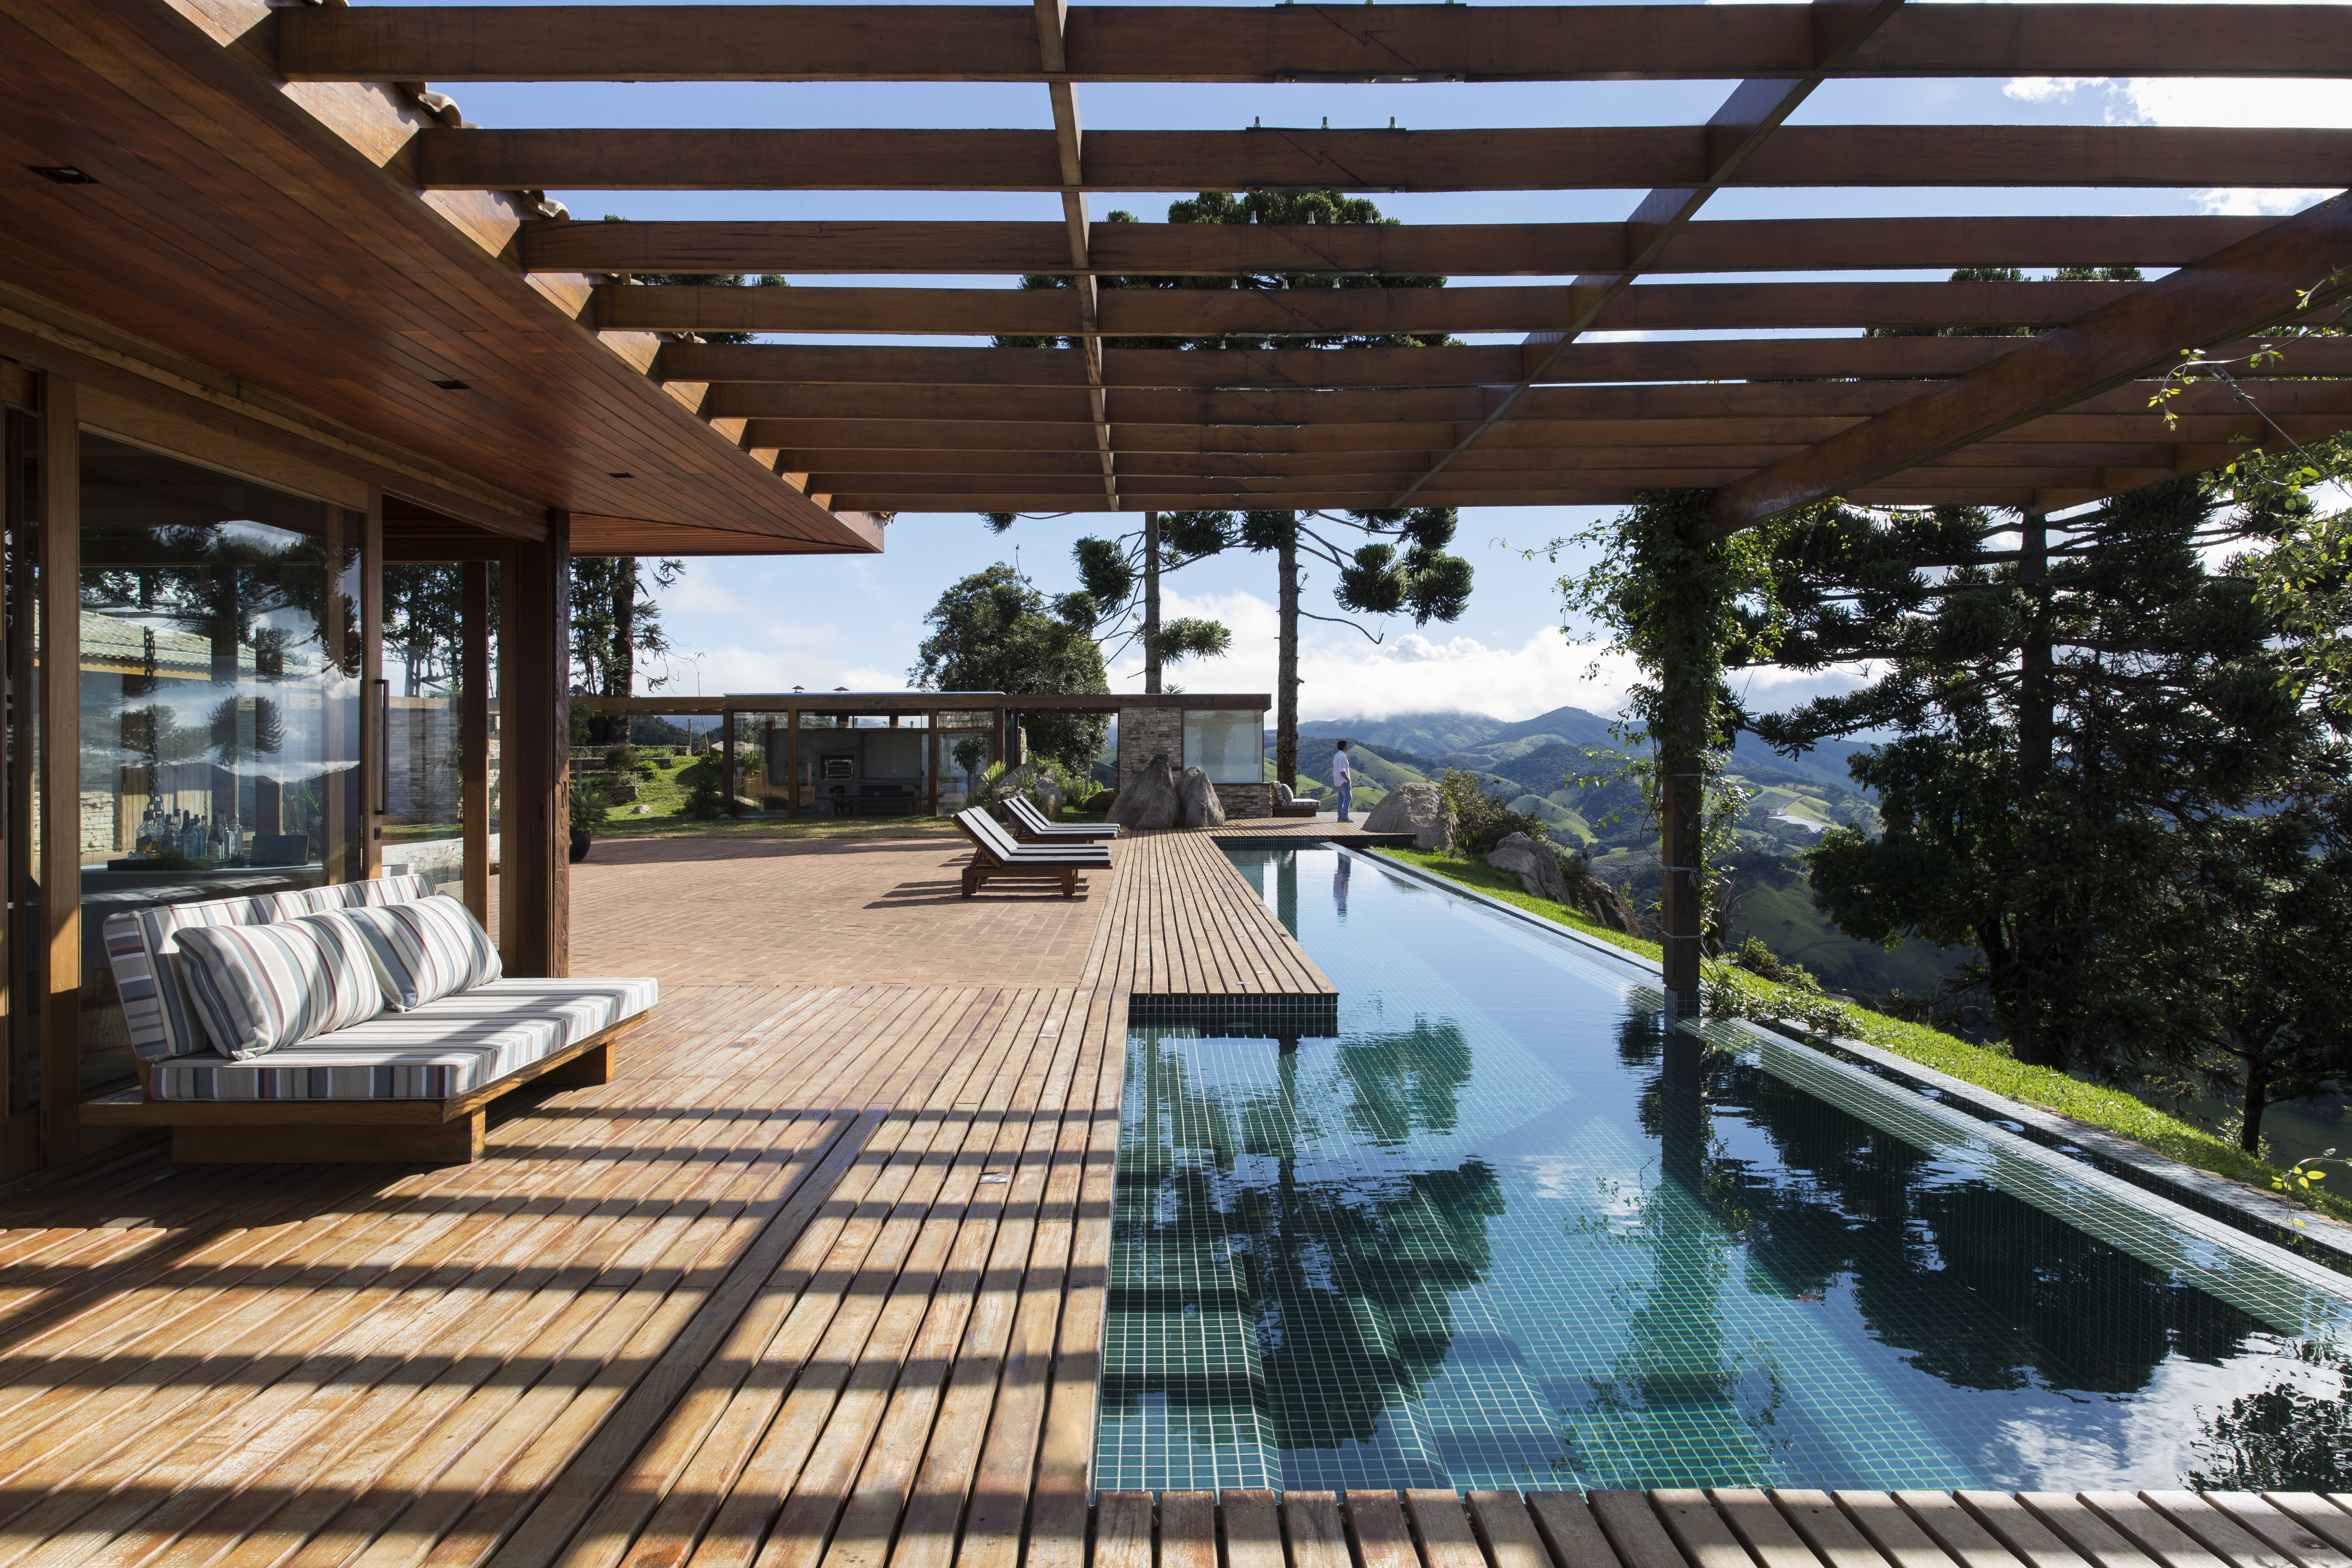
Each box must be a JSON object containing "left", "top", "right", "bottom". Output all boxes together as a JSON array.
[{"left": 0, "top": 0, "right": 880, "bottom": 552}]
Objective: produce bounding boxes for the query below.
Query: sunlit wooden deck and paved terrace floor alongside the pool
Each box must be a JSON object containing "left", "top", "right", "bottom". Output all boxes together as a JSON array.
[{"left": 0, "top": 834, "right": 2352, "bottom": 1568}]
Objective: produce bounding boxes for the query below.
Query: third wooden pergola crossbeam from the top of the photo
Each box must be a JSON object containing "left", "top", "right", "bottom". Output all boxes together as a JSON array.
[{"left": 515, "top": 212, "right": 2274, "bottom": 278}]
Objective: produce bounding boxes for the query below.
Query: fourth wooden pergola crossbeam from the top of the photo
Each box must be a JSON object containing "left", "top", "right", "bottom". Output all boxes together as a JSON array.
[{"left": 593, "top": 277, "right": 2136, "bottom": 338}]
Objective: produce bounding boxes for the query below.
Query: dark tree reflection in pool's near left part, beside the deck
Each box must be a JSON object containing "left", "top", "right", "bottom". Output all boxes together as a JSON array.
[{"left": 1103, "top": 1025, "right": 1503, "bottom": 1483}]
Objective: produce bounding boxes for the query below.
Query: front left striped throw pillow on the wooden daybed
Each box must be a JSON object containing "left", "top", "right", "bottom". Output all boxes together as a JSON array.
[{"left": 179, "top": 915, "right": 383, "bottom": 1060}]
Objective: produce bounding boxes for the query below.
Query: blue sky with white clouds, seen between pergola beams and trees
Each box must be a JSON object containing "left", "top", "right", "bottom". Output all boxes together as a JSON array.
[{"left": 404, "top": 0, "right": 2352, "bottom": 719}]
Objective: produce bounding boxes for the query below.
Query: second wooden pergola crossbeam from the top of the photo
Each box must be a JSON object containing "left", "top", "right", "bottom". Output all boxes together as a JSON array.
[{"left": 409, "top": 125, "right": 2352, "bottom": 193}]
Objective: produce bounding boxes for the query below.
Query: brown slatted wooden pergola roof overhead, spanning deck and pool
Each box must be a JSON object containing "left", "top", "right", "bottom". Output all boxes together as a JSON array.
[{"left": 275, "top": 0, "right": 2352, "bottom": 529}]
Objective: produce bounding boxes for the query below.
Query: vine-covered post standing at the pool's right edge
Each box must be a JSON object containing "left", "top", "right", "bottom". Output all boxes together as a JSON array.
[{"left": 1543, "top": 489, "right": 1790, "bottom": 1006}]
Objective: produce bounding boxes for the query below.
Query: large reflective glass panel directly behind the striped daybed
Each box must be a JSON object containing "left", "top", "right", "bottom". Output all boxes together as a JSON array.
[{"left": 75, "top": 433, "right": 367, "bottom": 1088}]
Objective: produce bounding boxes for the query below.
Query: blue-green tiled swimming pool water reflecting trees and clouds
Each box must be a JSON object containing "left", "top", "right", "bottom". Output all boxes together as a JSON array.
[{"left": 1096, "top": 849, "right": 2352, "bottom": 1490}]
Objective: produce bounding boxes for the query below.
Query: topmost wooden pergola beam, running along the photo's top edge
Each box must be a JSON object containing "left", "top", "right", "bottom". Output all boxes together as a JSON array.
[{"left": 275, "top": 5, "right": 2352, "bottom": 82}]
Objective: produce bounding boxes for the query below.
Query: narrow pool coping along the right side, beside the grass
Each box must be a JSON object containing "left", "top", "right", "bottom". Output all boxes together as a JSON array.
[{"left": 1324, "top": 839, "right": 2352, "bottom": 1274}]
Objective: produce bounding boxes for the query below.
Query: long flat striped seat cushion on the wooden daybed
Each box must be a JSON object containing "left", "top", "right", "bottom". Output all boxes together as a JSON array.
[{"left": 148, "top": 980, "right": 661, "bottom": 1100}]
